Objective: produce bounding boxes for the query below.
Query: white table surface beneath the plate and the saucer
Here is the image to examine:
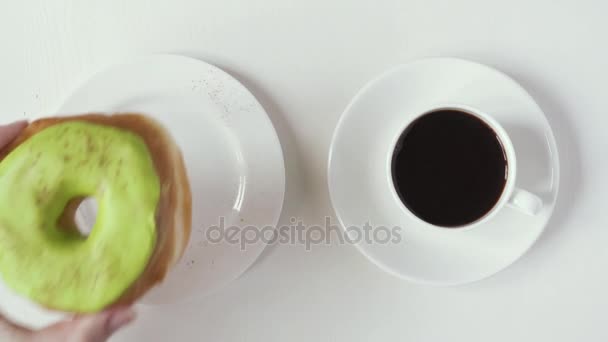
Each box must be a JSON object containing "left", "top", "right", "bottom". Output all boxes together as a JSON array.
[{"left": 0, "top": 0, "right": 608, "bottom": 342}]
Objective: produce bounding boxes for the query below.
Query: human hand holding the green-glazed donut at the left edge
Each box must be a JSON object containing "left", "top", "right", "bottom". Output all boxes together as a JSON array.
[{"left": 0, "top": 122, "right": 135, "bottom": 342}]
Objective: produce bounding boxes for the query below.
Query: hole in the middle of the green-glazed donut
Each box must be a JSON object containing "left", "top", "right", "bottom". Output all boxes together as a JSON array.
[{"left": 59, "top": 196, "right": 98, "bottom": 239}]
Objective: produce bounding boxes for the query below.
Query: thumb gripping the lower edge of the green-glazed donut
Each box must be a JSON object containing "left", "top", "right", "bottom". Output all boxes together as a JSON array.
[{"left": 33, "top": 308, "right": 135, "bottom": 342}]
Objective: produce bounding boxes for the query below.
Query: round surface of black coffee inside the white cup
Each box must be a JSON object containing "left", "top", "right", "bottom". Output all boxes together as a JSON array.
[{"left": 392, "top": 109, "right": 507, "bottom": 227}]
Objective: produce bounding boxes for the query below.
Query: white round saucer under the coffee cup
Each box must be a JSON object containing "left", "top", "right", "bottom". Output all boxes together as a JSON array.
[{"left": 328, "top": 58, "right": 559, "bottom": 285}]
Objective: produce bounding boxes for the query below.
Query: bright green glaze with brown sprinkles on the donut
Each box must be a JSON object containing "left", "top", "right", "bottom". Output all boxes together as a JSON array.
[{"left": 0, "top": 121, "right": 160, "bottom": 312}]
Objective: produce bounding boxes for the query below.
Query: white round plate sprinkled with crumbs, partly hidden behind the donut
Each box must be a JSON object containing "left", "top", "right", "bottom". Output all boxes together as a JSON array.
[{"left": 58, "top": 55, "right": 285, "bottom": 304}]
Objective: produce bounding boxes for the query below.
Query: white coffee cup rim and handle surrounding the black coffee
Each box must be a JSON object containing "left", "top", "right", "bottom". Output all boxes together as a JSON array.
[{"left": 386, "top": 104, "right": 543, "bottom": 231}]
